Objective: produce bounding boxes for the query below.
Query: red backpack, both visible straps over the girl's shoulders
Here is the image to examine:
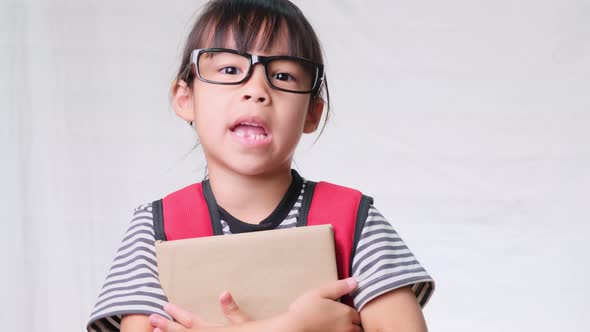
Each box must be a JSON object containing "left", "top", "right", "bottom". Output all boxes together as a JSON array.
[{"left": 152, "top": 181, "right": 373, "bottom": 306}]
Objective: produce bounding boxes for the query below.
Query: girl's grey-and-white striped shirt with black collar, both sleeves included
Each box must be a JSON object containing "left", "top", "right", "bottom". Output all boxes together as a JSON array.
[{"left": 87, "top": 179, "right": 434, "bottom": 331}]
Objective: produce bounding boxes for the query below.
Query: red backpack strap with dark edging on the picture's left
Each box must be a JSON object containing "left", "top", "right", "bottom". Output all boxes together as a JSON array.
[{"left": 152, "top": 181, "right": 223, "bottom": 241}]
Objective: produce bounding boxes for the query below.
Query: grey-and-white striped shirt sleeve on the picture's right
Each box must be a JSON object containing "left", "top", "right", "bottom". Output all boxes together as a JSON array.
[{"left": 352, "top": 206, "right": 435, "bottom": 311}]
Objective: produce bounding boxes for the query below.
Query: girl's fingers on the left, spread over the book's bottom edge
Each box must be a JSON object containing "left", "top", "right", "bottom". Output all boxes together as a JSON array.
[{"left": 149, "top": 292, "right": 251, "bottom": 332}]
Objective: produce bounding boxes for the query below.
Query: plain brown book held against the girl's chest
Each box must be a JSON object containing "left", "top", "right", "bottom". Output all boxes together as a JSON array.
[{"left": 156, "top": 225, "right": 338, "bottom": 324}]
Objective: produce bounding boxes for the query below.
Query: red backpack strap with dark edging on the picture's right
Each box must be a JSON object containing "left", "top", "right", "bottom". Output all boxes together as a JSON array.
[{"left": 297, "top": 181, "right": 373, "bottom": 306}]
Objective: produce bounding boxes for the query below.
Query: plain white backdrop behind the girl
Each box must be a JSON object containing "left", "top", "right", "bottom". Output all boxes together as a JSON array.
[{"left": 0, "top": 0, "right": 590, "bottom": 332}]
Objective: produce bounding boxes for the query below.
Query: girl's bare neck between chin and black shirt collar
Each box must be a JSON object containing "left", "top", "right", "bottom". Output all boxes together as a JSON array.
[{"left": 209, "top": 166, "right": 292, "bottom": 224}]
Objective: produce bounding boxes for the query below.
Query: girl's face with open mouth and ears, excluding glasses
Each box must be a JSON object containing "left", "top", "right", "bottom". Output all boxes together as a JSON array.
[{"left": 173, "top": 34, "right": 324, "bottom": 176}]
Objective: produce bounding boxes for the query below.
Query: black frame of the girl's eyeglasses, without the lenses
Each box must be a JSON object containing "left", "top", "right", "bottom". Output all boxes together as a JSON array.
[{"left": 191, "top": 47, "right": 324, "bottom": 94}]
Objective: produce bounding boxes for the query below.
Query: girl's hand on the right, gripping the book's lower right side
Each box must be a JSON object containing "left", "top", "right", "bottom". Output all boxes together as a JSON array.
[{"left": 286, "top": 278, "right": 362, "bottom": 332}]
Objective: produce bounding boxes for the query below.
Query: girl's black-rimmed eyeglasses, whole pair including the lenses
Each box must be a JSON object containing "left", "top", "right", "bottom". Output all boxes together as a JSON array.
[{"left": 191, "top": 48, "right": 324, "bottom": 93}]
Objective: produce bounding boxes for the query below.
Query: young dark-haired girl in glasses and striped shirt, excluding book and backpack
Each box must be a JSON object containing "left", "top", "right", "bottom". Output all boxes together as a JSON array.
[{"left": 87, "top": 0, "right": 434, "bottom": 332}]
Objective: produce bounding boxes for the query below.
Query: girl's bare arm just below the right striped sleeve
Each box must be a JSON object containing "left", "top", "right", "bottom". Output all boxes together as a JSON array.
[{"left": 360, "top": 286, "right": 428, "bottom": 332}]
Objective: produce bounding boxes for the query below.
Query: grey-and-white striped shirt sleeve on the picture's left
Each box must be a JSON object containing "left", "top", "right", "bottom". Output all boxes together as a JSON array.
[{"left": 86, "top": 204, "right": 171, "bottom": 332}]
